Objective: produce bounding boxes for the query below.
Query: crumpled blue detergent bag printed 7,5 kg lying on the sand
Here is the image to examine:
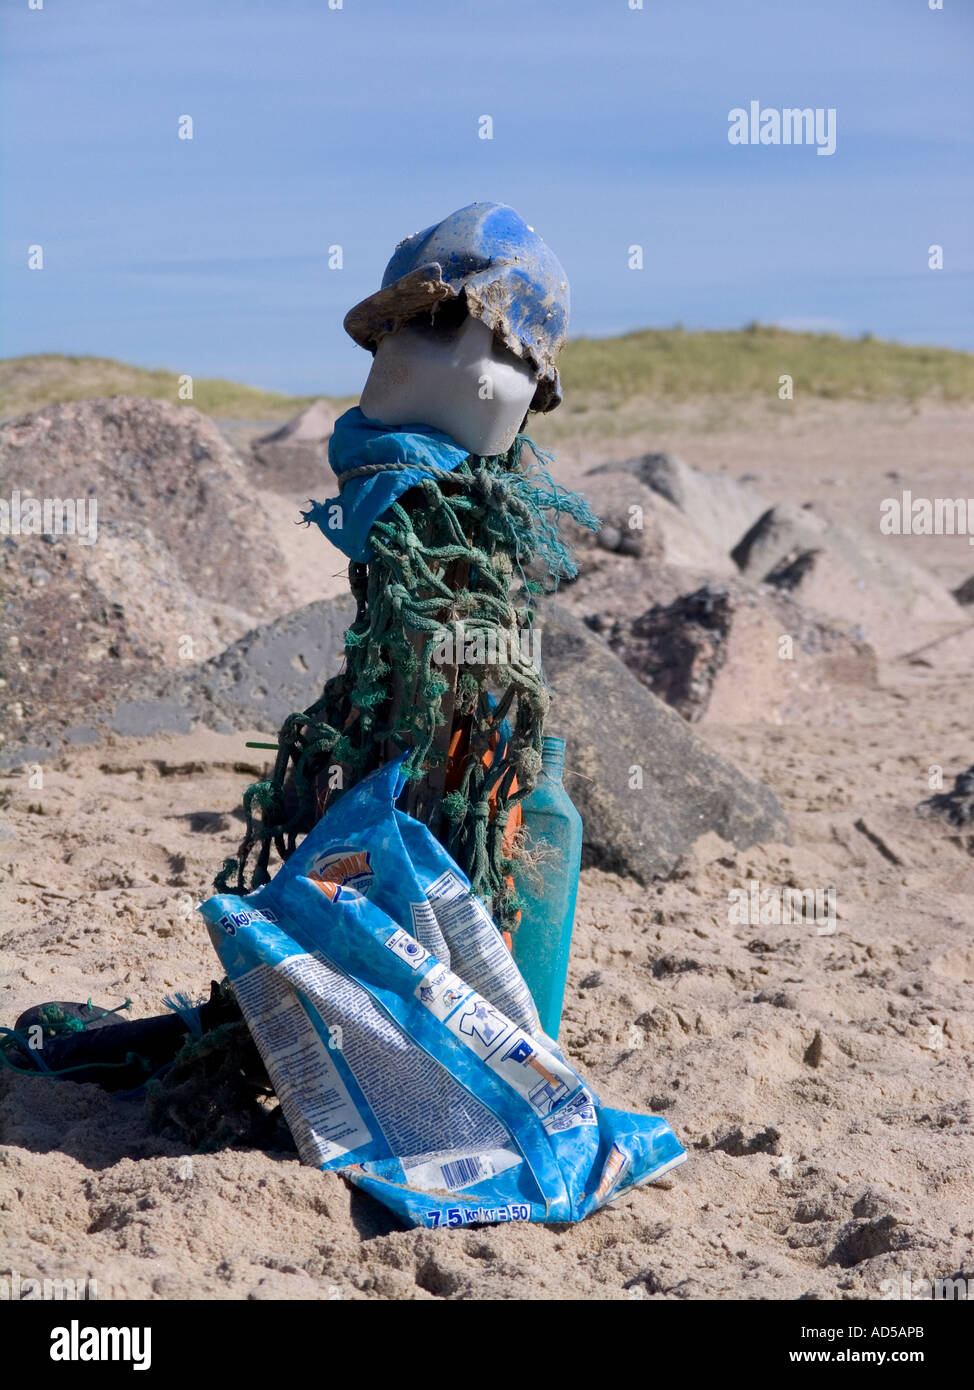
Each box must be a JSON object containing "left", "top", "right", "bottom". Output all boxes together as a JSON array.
[{"left": 200, "top": 760, "right": 686, "bottom": 1226}]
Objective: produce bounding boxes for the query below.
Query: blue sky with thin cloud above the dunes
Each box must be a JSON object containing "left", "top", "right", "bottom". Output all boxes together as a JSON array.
[{"left": 0, "top": 0, "right": 974, "bottom": 393}]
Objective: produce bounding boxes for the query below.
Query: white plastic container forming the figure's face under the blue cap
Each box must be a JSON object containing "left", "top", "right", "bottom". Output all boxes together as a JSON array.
[{"left": 358, "top": 317, "right": 538, "bottom": 455}]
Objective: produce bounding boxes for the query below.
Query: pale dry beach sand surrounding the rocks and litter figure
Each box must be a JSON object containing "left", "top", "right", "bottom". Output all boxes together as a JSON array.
[{"left": 0, "top": 404, "right": 974, "bottom": 1300}]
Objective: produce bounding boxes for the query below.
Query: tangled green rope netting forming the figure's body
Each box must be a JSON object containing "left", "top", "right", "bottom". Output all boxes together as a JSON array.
[{"left": 215, "top": 435, "right": 597, "bottom": 924}]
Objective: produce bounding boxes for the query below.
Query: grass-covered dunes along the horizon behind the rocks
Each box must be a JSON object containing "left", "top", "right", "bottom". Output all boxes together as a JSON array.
[{"left": 0, "top": 324, "right": 974, "bottom": 432}]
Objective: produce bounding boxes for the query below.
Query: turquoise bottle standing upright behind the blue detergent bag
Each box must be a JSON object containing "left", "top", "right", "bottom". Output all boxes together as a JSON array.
[{"left": 514, "top": 738, "right": 582, "bottom": 1038}]
